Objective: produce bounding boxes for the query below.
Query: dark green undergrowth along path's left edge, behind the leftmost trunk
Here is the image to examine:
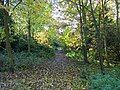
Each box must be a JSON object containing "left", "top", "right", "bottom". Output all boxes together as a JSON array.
[{"left": 0, "top": 45, "right": 54, "bottom": 71}]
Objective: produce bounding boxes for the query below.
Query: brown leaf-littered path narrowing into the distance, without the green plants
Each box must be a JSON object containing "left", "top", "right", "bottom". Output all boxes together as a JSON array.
[{"left": 0, "top": 51, "right": 88, "bottom": 90}]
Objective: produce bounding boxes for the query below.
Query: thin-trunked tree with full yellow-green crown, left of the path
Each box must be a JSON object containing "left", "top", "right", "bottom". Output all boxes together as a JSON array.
[{"left": 13, "top": 0, "right": 52, "bottom": 53}]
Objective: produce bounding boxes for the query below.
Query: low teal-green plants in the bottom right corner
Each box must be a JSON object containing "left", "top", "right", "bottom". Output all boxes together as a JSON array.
[{"left": 90, "top": 70, "right": 120, "bottom": 90}]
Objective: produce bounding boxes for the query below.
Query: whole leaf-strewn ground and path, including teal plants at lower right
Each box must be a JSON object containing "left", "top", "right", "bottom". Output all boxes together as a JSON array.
[{"left": 0, "top": 52, "right": 120, "bottom": 90}]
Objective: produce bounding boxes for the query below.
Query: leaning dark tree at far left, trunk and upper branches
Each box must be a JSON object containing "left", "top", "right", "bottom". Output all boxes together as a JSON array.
[{"left": 0, "top": 0, "right": 21, "bottom": 73}]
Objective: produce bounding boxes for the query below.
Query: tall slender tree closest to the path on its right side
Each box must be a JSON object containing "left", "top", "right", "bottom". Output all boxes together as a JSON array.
[{"left": 64, "top": 0, "right": 89, "bottom": 63}]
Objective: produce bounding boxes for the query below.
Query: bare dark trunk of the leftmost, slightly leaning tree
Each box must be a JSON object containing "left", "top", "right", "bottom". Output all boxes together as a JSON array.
[{"left": 0, "top": 0, "right": 14, "bottom": 73}]
